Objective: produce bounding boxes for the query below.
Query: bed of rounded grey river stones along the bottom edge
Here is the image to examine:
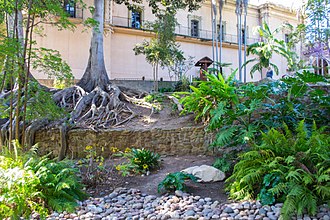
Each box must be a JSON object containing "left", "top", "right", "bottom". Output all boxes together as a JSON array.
[{"left": 48, "top": 188, "right": 330, "bottom": 220}]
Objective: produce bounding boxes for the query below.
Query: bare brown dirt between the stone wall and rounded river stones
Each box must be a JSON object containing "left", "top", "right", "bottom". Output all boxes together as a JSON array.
[{"left": 88, "top": 155, "right": 227, "bottom": 203}]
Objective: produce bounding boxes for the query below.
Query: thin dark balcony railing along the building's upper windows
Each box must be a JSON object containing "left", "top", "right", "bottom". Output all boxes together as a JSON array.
[{"left": 112, "top": 16, "right": 259, "bottom": 44}]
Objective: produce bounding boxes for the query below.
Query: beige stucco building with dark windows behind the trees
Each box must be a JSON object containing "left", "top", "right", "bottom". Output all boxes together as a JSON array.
[{"left": 34, "top": 0, "right": 300, "bottom": 81}]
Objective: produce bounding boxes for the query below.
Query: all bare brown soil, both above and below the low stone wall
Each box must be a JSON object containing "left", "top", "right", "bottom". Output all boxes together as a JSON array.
[{"left": 84, "top": 98, "right": 227, "bottom": 203}]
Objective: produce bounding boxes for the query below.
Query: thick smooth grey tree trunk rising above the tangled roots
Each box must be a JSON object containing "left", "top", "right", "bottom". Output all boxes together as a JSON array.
[{"left": 77, "top": 0, "right": 110, "bottom": 92}]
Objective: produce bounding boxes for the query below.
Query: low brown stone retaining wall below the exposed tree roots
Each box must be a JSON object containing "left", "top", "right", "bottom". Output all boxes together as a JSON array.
[{"left": 35, "top": 127, "right": 213, "bottom": 158}]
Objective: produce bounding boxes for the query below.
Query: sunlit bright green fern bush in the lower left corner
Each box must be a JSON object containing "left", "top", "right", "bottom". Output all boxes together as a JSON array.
[{"left": 0, "top": 144, "right": 86, "bottom": 219}]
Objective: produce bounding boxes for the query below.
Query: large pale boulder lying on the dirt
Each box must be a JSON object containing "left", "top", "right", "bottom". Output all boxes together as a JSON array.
[{"left": 181, "top": 165, "right": 226, "bottom": 183}]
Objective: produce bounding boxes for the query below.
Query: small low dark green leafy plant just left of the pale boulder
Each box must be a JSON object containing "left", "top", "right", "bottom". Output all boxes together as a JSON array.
[{"left": 158, "top": 172, "right": 197, "bottom": 192}]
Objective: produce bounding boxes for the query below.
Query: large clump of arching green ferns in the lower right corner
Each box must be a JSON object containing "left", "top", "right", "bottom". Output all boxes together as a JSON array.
[{"left": 227, "top": 121, "right": 330, "bottom": 219}]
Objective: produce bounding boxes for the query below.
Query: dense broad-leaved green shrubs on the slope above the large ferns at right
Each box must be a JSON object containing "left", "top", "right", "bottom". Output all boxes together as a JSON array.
[{"left": 178, "top": 72, "right": 330, "bottom": 148}]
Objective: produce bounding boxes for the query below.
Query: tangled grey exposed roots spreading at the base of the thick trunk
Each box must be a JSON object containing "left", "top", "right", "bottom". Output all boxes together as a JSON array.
[{"left": 53, "top": 84, "right": 136, "bottom": 129}]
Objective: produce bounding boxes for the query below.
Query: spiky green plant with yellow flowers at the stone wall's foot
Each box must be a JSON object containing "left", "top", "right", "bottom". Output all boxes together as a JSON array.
[{"left": 116, "top": 148, "right": 160, "bottom": 176}]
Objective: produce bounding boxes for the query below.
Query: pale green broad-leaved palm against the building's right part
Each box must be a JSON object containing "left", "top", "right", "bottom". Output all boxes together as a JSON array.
[{"left": 243, "top": 23, "right": 294, "bottom": 77}]
